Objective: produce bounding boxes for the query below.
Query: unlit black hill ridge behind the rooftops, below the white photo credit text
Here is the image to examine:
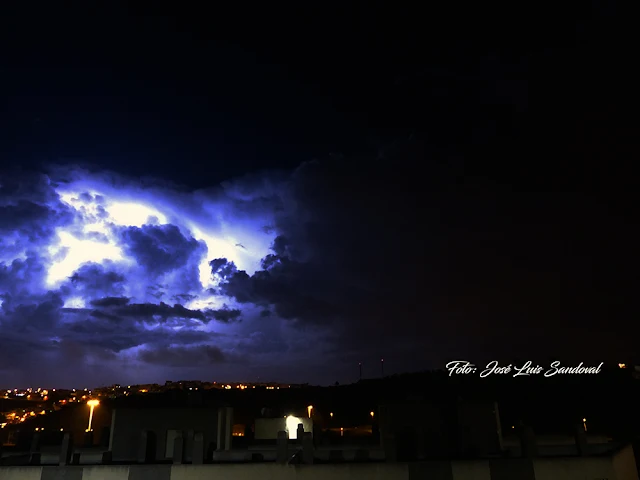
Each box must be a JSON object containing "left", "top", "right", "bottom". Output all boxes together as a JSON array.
[{"left": 100, "top": 368, "right": 640, "bottom": 436}]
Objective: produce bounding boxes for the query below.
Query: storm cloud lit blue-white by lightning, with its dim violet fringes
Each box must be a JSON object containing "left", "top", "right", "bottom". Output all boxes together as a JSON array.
[{"left": 0, "top": 163, "right": 400, "bottom": 384}]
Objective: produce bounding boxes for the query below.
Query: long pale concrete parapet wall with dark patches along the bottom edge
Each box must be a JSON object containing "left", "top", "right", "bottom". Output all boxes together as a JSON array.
[{"left": 0, "top": 446, "right": 639, "bottom": 480}]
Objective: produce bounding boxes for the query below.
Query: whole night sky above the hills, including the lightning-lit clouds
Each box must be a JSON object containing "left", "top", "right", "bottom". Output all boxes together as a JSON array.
[{"left": 0, "top": 2, "right": 640, "bottom": 387}]
